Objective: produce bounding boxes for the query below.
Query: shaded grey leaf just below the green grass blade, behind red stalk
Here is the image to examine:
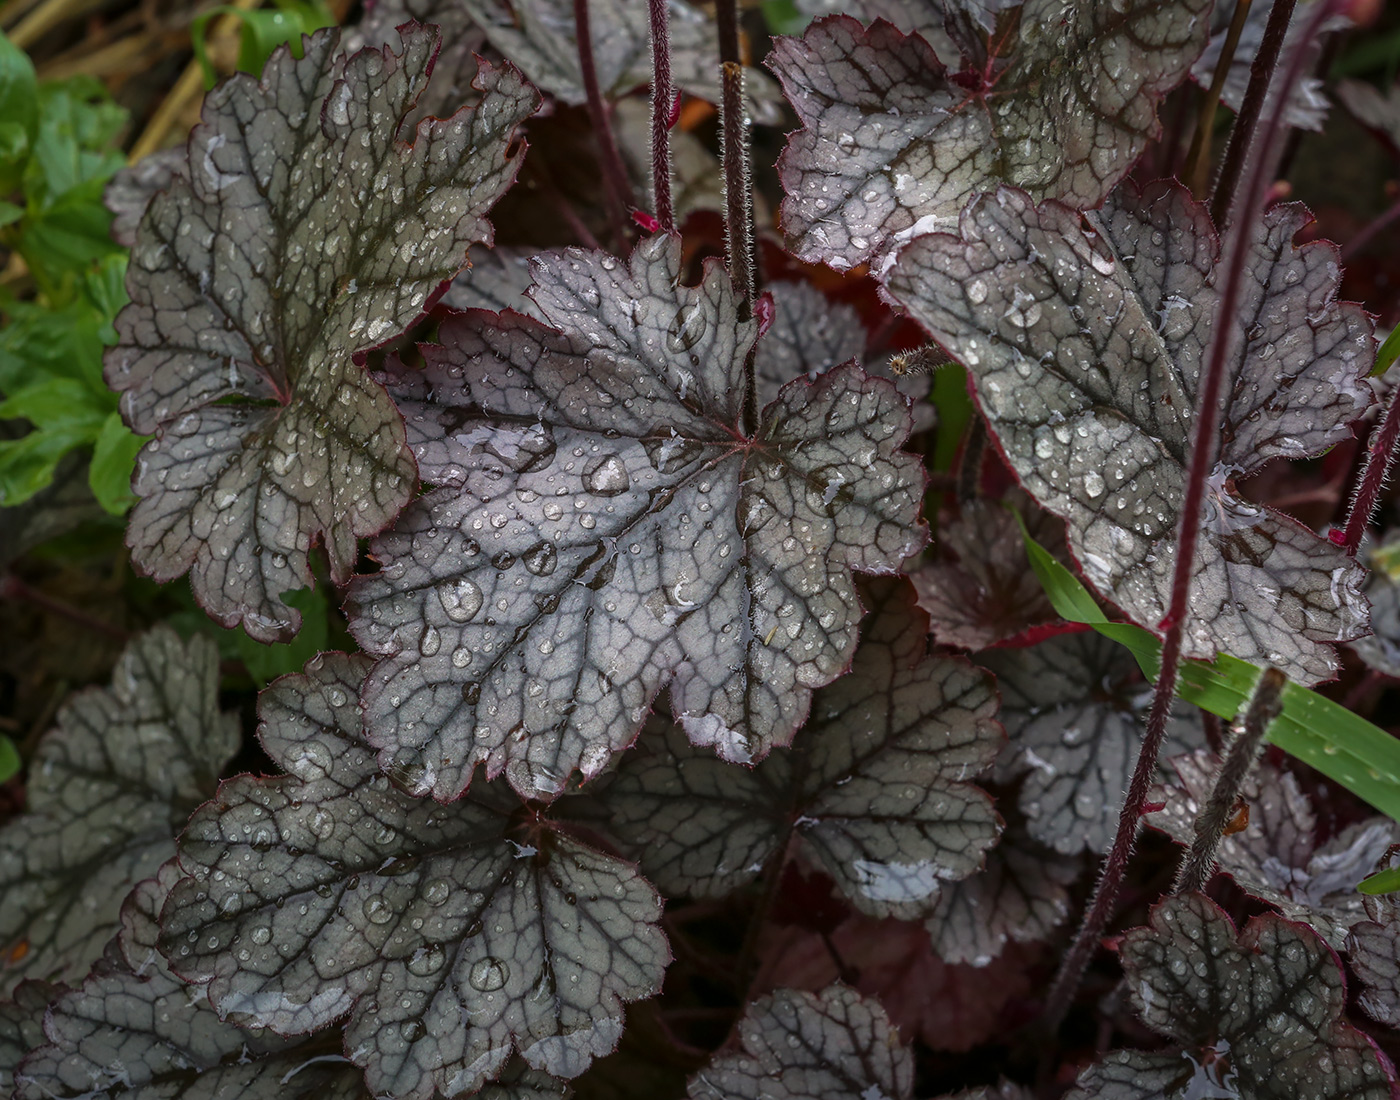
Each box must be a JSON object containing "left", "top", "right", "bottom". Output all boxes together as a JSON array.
[{"left": 977, "top": 631, "right": 1203, "bottom": 855}]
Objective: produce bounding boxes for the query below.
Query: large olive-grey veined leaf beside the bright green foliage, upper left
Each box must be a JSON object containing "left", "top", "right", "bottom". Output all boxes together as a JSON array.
[{"left": 106, "top": 28, "right": 538, "bottom": 641}]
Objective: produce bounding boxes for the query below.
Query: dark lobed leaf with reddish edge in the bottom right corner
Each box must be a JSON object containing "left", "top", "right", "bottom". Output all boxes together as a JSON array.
[{"left": 1067, "top": 893, "right": 1392, "bottom": 1100}]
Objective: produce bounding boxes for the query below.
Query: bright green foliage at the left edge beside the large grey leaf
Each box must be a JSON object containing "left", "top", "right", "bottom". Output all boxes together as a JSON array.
[{"left": 0, "top": 38, "right": 143, "bottom": 515}]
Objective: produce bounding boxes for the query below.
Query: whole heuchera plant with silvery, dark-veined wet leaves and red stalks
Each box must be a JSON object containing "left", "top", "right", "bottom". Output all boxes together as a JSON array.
[{"left": 10, "top": 0, "right": 1400, "bottom": 1100}]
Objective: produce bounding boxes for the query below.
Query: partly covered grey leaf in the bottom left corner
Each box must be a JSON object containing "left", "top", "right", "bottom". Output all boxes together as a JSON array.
[{"left": 15, "top": 861, "right": 367, "bottom": 1100}]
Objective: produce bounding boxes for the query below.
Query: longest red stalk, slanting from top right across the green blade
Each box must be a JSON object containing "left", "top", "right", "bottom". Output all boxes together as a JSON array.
[{"left": 1044, "top": 0, "right": 1334, "bottom": 1030}]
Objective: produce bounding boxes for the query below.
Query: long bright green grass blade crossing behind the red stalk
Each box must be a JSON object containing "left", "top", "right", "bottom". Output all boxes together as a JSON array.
[{"left": 1022, "top": 517, "right": 1400, "bottom": 822}]
